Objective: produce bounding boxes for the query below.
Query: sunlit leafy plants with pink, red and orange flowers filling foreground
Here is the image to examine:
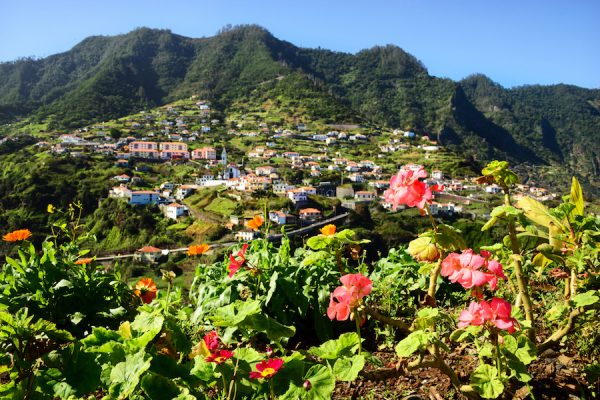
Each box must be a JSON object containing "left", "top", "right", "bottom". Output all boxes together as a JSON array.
[{"left": 0, "top": 162, "right": 600, "bottom": 399}]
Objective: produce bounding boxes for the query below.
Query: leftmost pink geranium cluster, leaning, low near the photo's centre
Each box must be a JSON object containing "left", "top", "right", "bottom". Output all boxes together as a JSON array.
[{"left": 327, "top": 274, "right": 373, "bottom": 321}]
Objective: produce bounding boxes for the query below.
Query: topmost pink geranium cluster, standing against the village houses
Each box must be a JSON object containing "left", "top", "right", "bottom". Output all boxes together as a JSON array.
[{"left": 383, "top": 167, "right": 444, "bottom": 211}]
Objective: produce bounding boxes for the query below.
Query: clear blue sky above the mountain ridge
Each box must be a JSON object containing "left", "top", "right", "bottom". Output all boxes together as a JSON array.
[{"left": 0, "top": 0, "right": 600, "bottom": 88}]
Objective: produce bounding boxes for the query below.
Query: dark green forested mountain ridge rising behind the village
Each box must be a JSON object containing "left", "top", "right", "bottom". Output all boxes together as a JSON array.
[{"left": 0, "top": 25, "right": 600, "bottom": 189}]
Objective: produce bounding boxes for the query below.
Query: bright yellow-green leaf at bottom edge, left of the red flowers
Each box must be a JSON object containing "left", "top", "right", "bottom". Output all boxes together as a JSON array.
[{"left": 109, "top": 350, "right": 150, "bottom": 399}]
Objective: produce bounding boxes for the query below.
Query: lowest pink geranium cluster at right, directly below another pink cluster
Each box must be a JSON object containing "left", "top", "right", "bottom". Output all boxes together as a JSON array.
[{"left": 458, "top": 297, "right": 517, "bottom": 333}]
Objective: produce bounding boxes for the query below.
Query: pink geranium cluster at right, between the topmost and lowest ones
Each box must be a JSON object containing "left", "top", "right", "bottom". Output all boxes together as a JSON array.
[{"left": 441, "top": 249, "right": 506, "bottom": 290}]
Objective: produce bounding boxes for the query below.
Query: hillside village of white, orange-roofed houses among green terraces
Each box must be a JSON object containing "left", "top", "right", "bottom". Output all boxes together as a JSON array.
[{"left": 37, "top": 97, "right": 556, "bottom": 245}]
